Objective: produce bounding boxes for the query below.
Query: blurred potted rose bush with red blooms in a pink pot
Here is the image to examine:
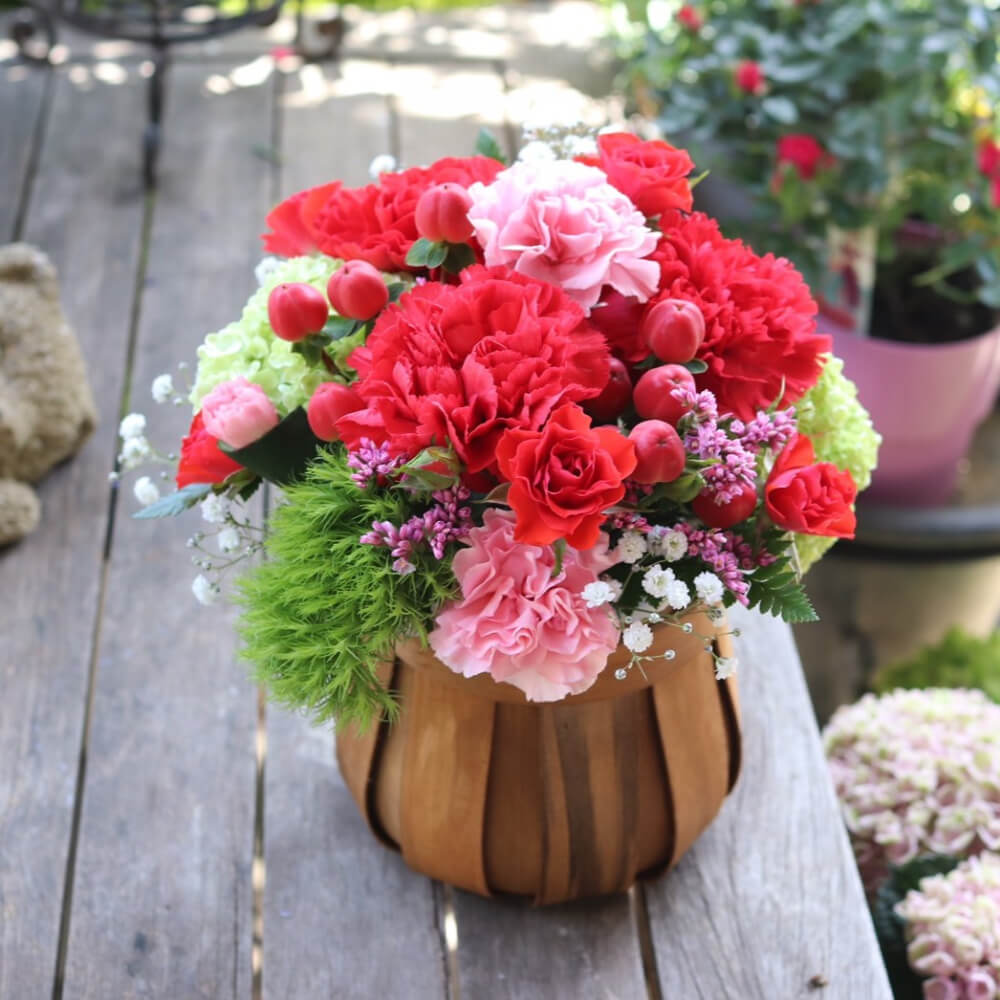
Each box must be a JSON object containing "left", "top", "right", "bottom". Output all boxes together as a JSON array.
[{"left": 618, "top": 0, "right": 1000, "bottom": 504}]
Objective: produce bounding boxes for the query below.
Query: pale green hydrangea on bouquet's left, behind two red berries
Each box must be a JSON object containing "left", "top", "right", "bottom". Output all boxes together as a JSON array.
[{"left": 190, "top": 256, "right": 346, "bottom": 414}]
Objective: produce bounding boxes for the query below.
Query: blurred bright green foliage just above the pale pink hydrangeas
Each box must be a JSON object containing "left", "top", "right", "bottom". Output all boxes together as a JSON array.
[{"left": 872, "top": 628, "right": 1000, "bottom": 702}]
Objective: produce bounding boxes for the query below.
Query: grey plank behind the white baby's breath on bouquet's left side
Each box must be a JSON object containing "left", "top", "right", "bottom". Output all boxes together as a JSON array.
[{"left": 65, "top": 63, "right": 273, "bottom": 1000}]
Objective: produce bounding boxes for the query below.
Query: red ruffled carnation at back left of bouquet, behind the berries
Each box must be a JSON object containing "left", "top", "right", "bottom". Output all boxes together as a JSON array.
[{"left": 263, "top": 156, "right": 503, "bottom": 271}]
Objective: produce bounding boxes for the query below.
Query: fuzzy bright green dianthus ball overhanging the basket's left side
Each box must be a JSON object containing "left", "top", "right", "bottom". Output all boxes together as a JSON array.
[{"left": 240, "top": 450, "right": 456, "bottom": 726}]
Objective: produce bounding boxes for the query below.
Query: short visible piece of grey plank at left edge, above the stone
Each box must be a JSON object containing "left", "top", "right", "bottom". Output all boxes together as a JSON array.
[{"left": 0, "top": 64, "right": 49, "bottom": 240}]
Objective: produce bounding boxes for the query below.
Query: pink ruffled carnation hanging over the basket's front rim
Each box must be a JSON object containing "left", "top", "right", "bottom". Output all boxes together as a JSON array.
[{"left": 430, "top": 509, "right": 618, "bottom": 701}]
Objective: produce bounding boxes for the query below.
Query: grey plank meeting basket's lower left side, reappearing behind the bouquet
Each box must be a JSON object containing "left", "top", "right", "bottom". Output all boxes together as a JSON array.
[{"left": 261, "top": 72, "right": 445, "bottom": 1000}]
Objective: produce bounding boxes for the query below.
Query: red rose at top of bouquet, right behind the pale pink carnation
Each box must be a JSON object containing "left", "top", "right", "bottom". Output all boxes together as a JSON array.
[{"left": 581, "top": 132, "right": 694, "bottom": 219}]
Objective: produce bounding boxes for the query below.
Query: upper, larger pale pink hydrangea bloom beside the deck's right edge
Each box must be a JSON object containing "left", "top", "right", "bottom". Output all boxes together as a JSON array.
[{"left": 824, "top": 689, "right": 1000, "bottom": 892}]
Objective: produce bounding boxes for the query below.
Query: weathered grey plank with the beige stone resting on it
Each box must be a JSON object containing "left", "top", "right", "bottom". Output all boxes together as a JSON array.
[{"left": 0, "top": 66, "right": 144, "bottom": 1000}]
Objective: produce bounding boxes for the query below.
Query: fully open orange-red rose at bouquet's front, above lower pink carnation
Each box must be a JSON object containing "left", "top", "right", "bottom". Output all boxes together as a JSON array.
[{"left": 497, "top": 405, "right": 636, "bottom": 549}]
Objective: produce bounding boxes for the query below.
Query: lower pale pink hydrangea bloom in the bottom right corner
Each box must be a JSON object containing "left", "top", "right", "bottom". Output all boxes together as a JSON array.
[{"left": 896, "top": 853, "right": 1000, "bottom": 1000}]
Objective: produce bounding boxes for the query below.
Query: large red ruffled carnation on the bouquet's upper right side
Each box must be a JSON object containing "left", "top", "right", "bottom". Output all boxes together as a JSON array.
[{"left": 652, "top": 212, "right": 831, "bottom": 420}]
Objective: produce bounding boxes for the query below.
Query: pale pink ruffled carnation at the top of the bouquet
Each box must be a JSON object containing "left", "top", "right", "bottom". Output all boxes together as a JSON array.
[{"left": 469, "top": 160, "right": 660, "bottom": 309}]
